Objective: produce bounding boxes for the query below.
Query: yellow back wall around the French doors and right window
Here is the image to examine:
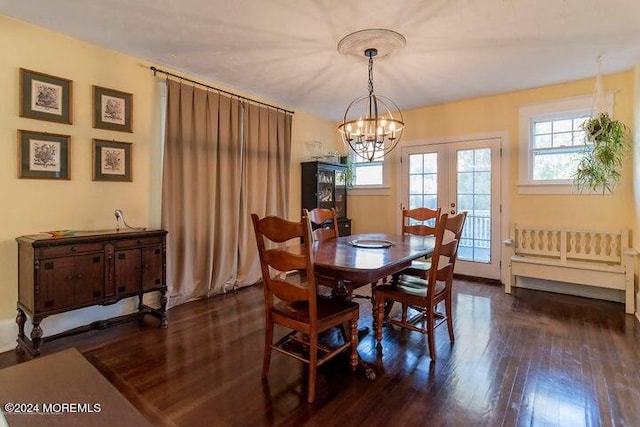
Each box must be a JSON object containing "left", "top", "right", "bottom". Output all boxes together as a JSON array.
[{"left": 349, "top": 71, "right": 636, "bottom": 236}]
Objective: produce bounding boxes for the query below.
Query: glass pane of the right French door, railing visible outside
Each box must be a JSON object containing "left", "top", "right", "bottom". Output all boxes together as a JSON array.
[{"left": 456, "top": 148, "right": 491, "bottom": 263}]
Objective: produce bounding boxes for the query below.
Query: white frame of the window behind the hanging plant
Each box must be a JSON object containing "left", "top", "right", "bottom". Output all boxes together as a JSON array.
[{"left": 518, "top": 92, "right": 613, "bottom": 194}]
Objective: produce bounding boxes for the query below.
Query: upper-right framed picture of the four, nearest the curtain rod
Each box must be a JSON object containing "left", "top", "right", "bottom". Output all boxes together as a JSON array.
[{"left": 93, "top": 86, "right": 133, "bottom": 132}]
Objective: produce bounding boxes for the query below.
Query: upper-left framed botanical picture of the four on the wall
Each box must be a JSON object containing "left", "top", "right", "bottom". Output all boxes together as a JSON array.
[{"left": 20, "top": 68, "right": 72, "bottom": 124}]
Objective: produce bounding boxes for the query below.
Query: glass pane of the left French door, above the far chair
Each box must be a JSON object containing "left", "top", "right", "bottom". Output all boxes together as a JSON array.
[{"left": 409, "top": 153, "right": 438, "bottom": 209}]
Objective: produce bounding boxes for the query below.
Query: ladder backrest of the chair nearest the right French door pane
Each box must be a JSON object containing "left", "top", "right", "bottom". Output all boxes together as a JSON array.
[{"left": 429, "top": 211, "right": 467, "bottom": 286}]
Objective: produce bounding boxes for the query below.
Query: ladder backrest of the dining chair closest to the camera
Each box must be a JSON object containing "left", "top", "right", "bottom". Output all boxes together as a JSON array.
[{"left": 251, "top": 214, "right": 317, "bottom": 319}]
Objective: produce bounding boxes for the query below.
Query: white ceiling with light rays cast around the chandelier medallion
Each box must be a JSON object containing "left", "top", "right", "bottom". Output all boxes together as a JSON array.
[{"left": 0, "top": 0, "right": 640, "bottom": 120}]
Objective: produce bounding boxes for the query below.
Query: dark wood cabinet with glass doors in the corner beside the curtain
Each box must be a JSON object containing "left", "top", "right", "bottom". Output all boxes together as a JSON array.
[{"left": 301, "top": 161, "right": 351, "bottom": 236}]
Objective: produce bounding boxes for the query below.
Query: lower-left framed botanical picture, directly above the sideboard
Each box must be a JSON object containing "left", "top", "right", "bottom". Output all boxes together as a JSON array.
[{"left": 18, "top": 130, "right": 70, "bottom": 179}]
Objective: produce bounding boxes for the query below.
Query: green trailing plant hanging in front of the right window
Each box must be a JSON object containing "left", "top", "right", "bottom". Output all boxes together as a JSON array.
[{"left": 573, "top": 113, "right": 630, "bottom": 194}]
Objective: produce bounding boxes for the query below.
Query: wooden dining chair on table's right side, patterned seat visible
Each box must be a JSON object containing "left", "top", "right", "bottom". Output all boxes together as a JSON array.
[{"left": 376, "top": 212, "right": 467, "bottom": 361}]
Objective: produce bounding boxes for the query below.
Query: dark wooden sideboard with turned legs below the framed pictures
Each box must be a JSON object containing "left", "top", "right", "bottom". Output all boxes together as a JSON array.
[{"left": 16, "top": 229, "right": 167, "bottom": 356}]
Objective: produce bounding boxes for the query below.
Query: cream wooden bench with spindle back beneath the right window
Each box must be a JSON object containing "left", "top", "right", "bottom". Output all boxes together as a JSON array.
[{"left": 503, "top": 224, "right": 637, "bottom": 314}]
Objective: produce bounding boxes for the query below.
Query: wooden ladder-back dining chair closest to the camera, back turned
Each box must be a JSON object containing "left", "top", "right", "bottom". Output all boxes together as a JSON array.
[{"left": 251, "top": 214, "right": 359, "bottom": 403}]
